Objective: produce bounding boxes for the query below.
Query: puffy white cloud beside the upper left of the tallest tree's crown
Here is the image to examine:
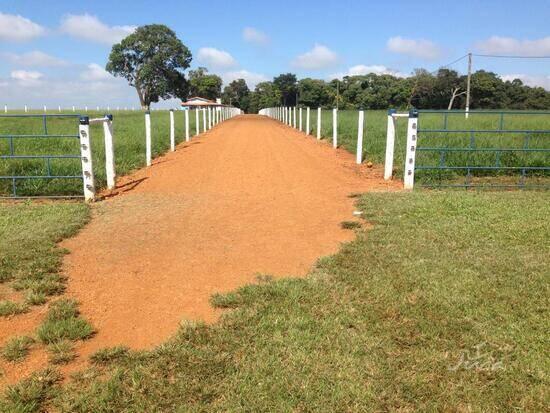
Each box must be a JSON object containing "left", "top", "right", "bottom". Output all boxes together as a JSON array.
[{"left": 61, "top": 14, "right": 136, "bottom": 45}]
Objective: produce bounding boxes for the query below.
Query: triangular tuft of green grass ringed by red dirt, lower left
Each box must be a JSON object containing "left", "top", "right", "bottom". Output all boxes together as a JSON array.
[{"left": 37, "top": 299, "right": 94, "bottom": 344}]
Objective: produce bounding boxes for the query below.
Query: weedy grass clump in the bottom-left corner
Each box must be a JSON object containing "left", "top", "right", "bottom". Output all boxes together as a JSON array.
[{"left": 0, "top": 368, "right": 61, "bottom": 413}]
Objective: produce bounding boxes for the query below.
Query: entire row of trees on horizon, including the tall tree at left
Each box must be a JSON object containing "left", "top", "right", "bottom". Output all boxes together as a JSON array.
[{"left": 106, "top": 24, "right": 550, "bottom": 113}]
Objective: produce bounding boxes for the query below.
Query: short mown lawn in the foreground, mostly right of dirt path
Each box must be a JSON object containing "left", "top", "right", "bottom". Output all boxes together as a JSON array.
[{"left": 0, "top": 191, "right": 550, "bottom": 412}]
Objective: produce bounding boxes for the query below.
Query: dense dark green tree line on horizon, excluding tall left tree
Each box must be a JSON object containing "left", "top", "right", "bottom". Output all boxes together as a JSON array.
[{"left": 221, "top": 69, "right": 550, "bottom": 113}]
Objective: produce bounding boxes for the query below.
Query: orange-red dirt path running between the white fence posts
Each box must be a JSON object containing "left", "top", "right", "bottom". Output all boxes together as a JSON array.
[{"left": 0, "top": 115, "right": 400, "bottom": 382}]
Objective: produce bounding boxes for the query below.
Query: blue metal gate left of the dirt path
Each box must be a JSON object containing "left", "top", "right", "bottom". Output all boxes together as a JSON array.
[{"left": 0, "top": 114, "right": 83, "bottom": 198}]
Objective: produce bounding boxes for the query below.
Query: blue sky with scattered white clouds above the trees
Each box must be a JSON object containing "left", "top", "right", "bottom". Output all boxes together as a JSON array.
[{"left": 0, "top": 0, "right": 550, "bottom": 107}]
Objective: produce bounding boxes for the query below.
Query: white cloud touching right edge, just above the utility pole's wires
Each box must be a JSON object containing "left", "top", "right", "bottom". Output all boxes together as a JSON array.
[{"left": 476, "top": 36, "right": 550, "bottom": 56}]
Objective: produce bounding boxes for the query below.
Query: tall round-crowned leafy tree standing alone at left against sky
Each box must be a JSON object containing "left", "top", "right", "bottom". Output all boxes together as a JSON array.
[{"left": 106, "top": 24, "right": 191, "bottom": 109}]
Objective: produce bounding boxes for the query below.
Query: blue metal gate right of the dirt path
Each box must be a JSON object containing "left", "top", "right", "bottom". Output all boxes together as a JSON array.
[{"left": 411, "top": 110, "right": 550, "bottom": 189}]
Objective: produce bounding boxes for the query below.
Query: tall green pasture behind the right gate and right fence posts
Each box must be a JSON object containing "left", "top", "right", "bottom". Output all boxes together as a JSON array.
[{"left": 303, "top": 110, "right": 550, "bottom": 185}]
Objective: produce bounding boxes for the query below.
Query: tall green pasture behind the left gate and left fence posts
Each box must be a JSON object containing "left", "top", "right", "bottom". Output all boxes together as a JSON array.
[{"left": 0, "top": 110, "right": 203, "bottom": 196}]
